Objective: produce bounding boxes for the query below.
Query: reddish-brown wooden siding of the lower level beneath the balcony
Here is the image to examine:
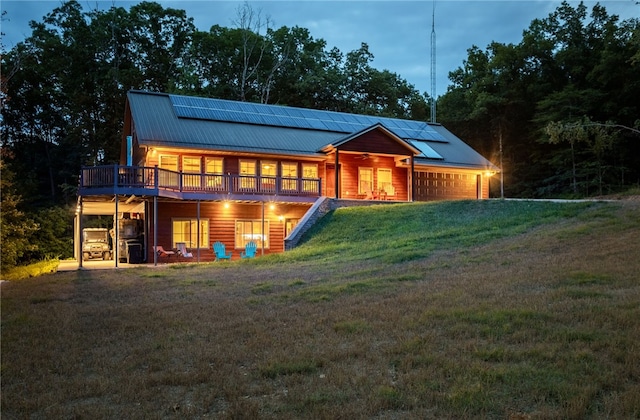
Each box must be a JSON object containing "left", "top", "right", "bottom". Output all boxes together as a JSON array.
[{"left": 147, "top": 201, "right": 310, "bottom": 262}]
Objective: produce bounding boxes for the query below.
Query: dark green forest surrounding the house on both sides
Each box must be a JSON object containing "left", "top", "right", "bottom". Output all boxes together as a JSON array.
[{"left": 0, "top": 1, "right": 640, "bottom": 267}]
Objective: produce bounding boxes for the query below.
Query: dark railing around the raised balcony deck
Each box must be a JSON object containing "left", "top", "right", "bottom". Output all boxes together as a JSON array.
[{"left": 80, "top": 165, "right": 321, "bottom": 197}]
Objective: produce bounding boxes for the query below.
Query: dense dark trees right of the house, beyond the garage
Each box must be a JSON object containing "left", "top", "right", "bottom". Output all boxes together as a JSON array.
[{"left": 438, "top": 2, "right": 640, "bottom": 197}]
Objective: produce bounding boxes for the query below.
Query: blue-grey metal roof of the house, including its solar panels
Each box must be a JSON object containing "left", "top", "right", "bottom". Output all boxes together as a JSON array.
[{"left": 127, "top": 91, "right": 497, "bottom": 170}]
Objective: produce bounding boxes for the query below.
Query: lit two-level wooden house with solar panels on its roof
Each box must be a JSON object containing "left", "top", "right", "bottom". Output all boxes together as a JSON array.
[{"left": 76, "top": 91, "right": 498, "bottom": 266}]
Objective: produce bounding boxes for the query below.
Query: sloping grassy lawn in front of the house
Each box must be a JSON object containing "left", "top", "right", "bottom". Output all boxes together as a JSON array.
[{"left": 0, "top": 200, "right": 640, "bottom": 419}]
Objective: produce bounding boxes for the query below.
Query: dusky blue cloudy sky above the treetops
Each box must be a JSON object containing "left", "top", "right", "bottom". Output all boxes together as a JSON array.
[{"left": 0, "top": 0, "right": 640, "bottom": 97}]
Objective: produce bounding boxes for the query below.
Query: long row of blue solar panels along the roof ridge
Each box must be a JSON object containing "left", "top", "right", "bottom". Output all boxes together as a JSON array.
[{"left": 169, "top": 95, "right": 446, "bottom": 142}]
